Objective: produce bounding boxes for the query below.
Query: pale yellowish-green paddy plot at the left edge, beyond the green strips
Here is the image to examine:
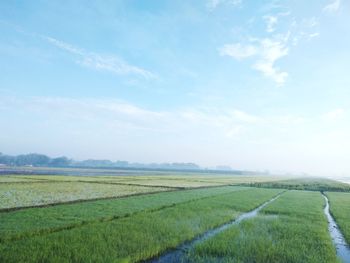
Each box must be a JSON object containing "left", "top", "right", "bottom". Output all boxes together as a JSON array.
[{"left": 0, "top": 182, "right": 169, "bottom": 209}]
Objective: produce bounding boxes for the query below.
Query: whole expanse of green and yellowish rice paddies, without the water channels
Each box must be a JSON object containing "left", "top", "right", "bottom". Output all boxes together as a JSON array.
[{"left": 0, "top": 174, "right": 350, "bottom": 262}]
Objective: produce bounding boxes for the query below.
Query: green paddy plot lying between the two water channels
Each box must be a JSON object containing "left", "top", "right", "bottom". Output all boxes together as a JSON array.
[{"left": 189, "top": 191, "right": 338, "bottom": 263}]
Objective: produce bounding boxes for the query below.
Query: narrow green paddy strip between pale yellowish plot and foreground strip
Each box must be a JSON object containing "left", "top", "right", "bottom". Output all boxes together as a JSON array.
[{"left": 0, "top": 186, "right": 246, "bottom": 241}]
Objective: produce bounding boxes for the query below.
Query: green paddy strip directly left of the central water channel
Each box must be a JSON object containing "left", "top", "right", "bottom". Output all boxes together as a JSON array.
[{"left": 0, "top": 189, "right": 280, "bottom": 262}]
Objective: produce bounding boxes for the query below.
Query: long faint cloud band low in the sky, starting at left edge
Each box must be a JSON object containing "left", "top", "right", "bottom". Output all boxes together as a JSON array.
[{"left": 0, "top": 96, "right": 290, "bottom": 138}]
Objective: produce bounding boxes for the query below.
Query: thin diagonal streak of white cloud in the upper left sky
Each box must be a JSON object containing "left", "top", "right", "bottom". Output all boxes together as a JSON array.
[{"left": 43, "top": 36, "right": 157, "bottom": 79}]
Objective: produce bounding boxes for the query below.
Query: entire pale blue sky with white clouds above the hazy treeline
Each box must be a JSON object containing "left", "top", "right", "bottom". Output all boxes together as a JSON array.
[{"left": 0, "top": 0, "right": 350, "bottom": 176}]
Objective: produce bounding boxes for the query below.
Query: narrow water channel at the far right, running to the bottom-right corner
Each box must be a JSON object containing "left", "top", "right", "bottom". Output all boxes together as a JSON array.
[{"left": 322, "top": 193, "right": 350, "bottom": 263}]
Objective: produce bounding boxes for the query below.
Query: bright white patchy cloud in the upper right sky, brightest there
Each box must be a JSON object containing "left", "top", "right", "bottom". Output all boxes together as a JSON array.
[{"left": 218, "top": 2, "right": 326, "bottom": 86}]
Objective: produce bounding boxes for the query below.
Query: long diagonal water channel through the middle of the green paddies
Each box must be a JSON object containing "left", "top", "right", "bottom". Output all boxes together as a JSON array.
[{"left": 144, "top": 194, "right": 281, "bottom": 263}]
